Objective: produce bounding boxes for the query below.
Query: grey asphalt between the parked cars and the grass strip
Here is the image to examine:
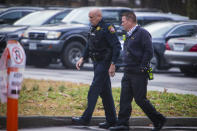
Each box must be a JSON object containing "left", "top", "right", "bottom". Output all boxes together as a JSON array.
[{"left": 24, "top": 64, "right": 197, "bottom": 95}]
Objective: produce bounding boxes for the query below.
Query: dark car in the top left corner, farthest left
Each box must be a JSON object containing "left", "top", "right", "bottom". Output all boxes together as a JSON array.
[{"left": 0, "top": 7, "right": 44, "bottom": 24}]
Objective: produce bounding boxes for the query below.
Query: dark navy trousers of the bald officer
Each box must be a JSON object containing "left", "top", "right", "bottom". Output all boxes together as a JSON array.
[{"left": 82, "top": 61, "right": 117, "bottom": 123}]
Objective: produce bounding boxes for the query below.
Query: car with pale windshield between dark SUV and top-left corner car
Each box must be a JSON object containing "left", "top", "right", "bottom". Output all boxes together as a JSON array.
[{"left": 0, "top": 8, "right": 71, "bottom": 56}]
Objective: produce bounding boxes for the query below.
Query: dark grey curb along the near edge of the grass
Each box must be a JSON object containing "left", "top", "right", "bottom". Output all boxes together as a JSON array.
[{"left": 0, "top": 116, "right": 197, "bottom": 129}]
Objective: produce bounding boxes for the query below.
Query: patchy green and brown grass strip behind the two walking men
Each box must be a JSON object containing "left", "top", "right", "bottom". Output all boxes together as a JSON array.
[{"left": 0, "top": 79, "right": 197, "bottom": 117}]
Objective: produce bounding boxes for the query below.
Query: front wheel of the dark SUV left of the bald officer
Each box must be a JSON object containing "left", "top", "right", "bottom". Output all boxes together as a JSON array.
[{"left": 61, "top": 41, "right": 84, "bottom": 69}]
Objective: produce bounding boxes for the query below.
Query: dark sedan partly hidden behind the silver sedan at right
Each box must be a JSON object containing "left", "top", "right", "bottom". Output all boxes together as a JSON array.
[{"left": 144, "top": 21, "right": 197, "bottom": 71}]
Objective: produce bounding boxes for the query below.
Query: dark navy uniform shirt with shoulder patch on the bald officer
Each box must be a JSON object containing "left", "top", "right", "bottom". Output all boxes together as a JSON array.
[{"left": 82, "top": 19, "right": 121, "bottom": 63}]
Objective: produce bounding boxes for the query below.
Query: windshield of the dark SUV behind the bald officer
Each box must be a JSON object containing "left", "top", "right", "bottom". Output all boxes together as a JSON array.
[{"left": 62, "top": 8, "right": 90, "bottom": 25}]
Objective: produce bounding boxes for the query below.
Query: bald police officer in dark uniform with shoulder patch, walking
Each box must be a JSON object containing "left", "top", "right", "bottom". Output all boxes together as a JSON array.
[{"left": 72, "top": 9, "right": 121, "bottom": 129}]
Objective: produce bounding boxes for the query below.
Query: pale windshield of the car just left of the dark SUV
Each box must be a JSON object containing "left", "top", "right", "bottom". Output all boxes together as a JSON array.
[{"left": 13, "top": 11, "right": 59, "bottom": 26}]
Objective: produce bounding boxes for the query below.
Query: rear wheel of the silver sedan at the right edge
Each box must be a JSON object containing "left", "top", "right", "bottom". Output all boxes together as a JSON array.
[{"left": 180, "top": 66, "right": 197, "bottom": 76}]
